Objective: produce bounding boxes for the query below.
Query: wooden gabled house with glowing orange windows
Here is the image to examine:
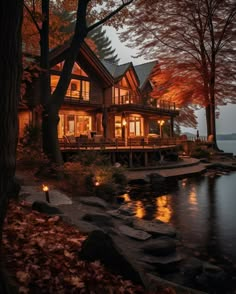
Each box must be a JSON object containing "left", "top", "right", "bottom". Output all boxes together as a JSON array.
[{"left": 19, "top": 43, "right": 178, "bottom": 146}]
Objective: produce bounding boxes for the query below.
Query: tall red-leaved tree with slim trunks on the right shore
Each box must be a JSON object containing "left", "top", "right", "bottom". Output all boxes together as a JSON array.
[{"left": 121, "top": 0, "right": 236, "bottom": 147}]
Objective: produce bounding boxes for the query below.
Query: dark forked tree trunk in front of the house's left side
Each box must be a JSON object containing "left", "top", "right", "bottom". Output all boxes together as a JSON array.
[{"left": 23, "top": 0, "right": 133, "bottom": 165}]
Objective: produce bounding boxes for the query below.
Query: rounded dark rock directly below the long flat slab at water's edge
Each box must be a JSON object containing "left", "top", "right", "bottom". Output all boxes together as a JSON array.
[{"left": 142, "top": 237, "right": 176, "bottom": 256}]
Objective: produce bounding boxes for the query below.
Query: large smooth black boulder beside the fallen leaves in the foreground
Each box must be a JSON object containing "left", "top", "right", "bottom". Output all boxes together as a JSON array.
[{"left": 80, "top": 231, "right": 143, "bottom": 284}]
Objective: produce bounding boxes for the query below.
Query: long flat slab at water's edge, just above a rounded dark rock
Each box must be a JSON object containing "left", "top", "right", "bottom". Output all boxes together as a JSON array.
[{"left": 133, "top": 219, "right": 176, "bottom": 237}]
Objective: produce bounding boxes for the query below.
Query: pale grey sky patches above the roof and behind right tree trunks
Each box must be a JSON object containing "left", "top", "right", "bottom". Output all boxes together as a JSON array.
[{"left": 106, "top": 27, "right": 236, "bottom": 136}]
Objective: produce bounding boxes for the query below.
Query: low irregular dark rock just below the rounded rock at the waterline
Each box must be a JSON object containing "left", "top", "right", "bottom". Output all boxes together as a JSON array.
[{"left": 140, "top": 252, "right": 183, "bottom": 273}]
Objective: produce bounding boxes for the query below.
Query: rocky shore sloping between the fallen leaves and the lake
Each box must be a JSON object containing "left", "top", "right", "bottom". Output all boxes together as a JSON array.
[{"left": 12, "top": 158, "right": 236, "bottom": 293}]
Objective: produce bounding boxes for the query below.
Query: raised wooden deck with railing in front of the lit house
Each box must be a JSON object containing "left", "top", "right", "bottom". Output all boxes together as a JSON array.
[{"left": 61, "top": 138, "right": 181, "bottom": 168}]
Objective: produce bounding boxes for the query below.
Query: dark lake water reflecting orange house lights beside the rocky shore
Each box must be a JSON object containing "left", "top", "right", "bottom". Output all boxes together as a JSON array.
[{"left": 125, "top": 172, "right": 236, "bottom": 280}]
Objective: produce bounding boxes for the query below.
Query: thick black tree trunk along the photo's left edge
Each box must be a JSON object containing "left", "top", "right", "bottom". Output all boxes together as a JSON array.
[{"left": 0, "top": 0, "right": 23, "bottom": 294}]
